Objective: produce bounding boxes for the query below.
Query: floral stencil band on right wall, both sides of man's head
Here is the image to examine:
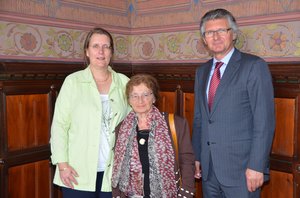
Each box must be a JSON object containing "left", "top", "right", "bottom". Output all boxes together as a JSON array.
[{"left": 128, "top": 22, "right": 300, "bottom": 61}]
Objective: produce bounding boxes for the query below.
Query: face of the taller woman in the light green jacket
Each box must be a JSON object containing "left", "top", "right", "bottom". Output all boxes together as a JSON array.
[{"left": 86, "top": 34, "right": 112, "bottom": 68}]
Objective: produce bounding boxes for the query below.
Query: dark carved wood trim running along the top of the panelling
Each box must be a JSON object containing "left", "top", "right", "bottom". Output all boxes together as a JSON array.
[{"left": 0, "top": 61, "right": 300, "bottom": 86}]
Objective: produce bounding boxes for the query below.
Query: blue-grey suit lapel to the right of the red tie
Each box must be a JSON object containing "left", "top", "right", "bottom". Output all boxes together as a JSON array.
[{"left": 211, "top": 49, "right": 241, "bottom": 115}]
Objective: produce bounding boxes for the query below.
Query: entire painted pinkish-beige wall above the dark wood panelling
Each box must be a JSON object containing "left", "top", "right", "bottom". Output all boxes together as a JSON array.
[{"left": 0, "top": 0, "right": 300, "bottom": 62}]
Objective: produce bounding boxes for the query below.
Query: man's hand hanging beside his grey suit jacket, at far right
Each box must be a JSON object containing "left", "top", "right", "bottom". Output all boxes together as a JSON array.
[{"left": 245, "top": 168, "right": 264, "bottom": 192}]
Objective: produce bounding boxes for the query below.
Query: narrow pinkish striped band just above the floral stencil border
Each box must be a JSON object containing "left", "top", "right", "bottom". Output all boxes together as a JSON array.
[{"left": 0, "top": 11, "right": 300, "bottom": 35}]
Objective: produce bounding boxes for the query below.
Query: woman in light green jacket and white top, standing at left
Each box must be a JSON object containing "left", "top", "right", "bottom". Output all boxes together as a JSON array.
[{"left": 50, "top": 28, "right": 130, "bottom": 198}]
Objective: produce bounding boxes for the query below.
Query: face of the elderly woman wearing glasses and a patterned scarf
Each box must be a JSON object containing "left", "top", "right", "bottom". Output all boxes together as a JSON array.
[{"left": 129, "top": 83, "right": 155, "bottom": 114}]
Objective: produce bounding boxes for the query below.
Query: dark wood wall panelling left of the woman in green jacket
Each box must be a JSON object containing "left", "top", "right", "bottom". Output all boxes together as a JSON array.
[{"left": 0, "top": 61, "right": 82, "bottom": 198}]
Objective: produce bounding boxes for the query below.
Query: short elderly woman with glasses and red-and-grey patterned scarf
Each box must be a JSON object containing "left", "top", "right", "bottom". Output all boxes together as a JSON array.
[{"left": 112, "top": 74, "right": 194, "bottom": 198}]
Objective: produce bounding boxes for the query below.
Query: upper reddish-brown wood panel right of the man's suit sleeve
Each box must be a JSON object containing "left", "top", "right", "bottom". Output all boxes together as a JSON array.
[{"left": 272, "top": 98, "right": 296, "bottom": 157}]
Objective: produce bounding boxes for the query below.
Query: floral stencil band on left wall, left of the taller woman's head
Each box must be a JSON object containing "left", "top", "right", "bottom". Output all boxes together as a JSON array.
[{"left": 0, "top": 23, "right": 85, "bottom": 60}]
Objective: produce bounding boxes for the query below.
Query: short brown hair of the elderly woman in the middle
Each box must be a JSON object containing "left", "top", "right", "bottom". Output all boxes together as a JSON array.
[{"left": 126, "top": 74, "right": 160, "bottom": 100}]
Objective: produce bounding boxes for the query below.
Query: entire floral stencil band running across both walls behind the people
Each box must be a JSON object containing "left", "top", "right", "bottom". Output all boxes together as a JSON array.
[{"left": 0, "top": 22, "right": 300, "bottom": 62}]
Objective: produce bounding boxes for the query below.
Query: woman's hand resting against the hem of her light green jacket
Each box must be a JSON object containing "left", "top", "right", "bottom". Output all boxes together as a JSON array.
[{"left": 58, "top": 162, "right": 78, "bottom": 189}]
